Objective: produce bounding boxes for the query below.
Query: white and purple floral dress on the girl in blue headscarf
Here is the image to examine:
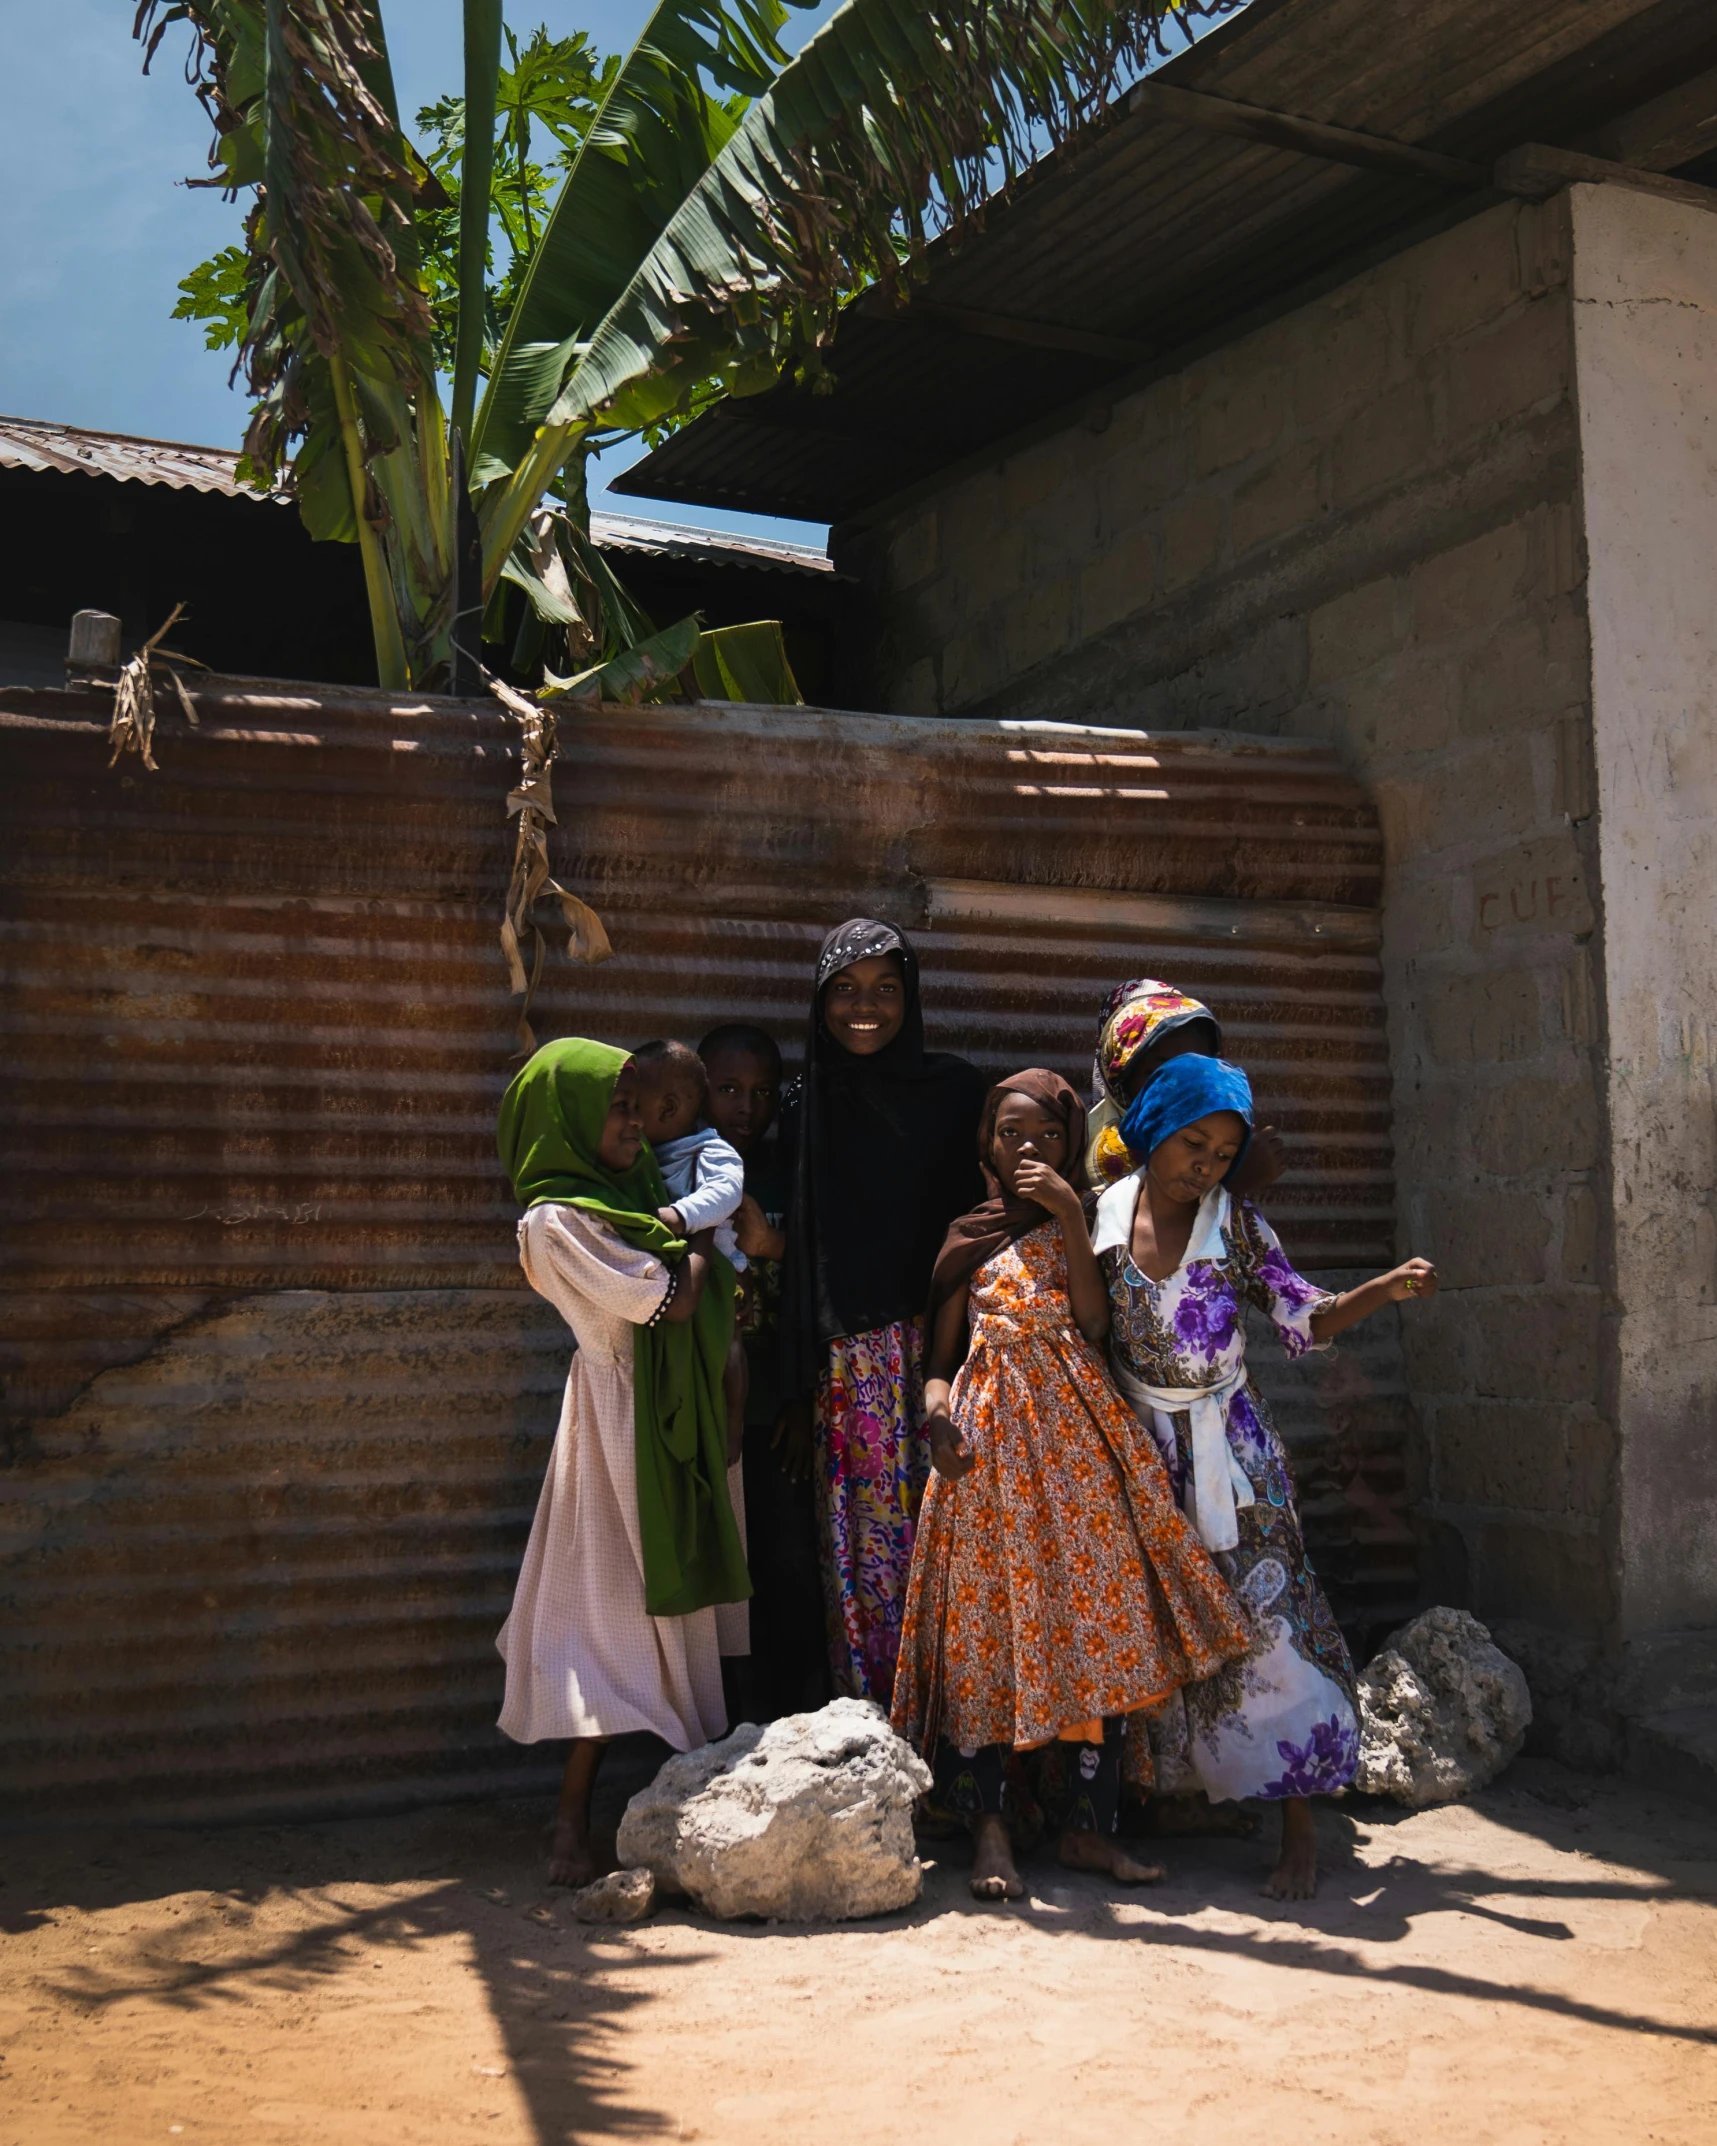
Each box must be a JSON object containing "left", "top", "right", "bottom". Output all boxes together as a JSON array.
[{"left": 1101, "top": 1193, "right": 1359, "bottom": 1800}]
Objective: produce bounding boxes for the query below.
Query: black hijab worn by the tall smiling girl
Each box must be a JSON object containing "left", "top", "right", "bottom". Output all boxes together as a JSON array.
[{"left": 781, "top": 916, "right": 983, "bottom": 1399}]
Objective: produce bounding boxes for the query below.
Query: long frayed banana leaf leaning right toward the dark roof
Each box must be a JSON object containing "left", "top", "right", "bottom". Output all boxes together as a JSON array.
[{"left": 483, "top": 0, "right": 1243, "bottom": 575}]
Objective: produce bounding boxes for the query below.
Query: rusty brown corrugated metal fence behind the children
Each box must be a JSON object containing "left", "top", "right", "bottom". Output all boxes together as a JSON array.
[{"left": 0, "top": 680, "right": 1410, "bottom": 1811}]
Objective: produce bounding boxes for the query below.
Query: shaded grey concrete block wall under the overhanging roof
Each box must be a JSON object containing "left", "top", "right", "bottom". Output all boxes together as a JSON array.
[{"left": 837, "top": 197, "right": 1616, "bottom": 1673}]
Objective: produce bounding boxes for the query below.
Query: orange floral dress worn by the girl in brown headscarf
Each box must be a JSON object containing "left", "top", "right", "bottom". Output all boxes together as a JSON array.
[{"left": 893, "top": 1221, "right": 1251, "bottom": 1758}]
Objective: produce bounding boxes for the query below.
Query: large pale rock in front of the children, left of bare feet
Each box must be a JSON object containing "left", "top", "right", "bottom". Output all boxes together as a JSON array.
[{"left": 618, "top": 1700, "right": 929, "bottom": 1923}]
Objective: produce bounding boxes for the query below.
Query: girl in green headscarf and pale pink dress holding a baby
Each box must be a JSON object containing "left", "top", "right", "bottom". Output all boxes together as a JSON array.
[{"left": 496, "top": 1037, "right": 751, "bottom": 1884}]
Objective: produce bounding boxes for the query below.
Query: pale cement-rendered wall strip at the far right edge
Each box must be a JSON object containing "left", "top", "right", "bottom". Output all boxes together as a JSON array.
[{"left": 1571, "top": 187, "right": 1717, "bottom": 1656}]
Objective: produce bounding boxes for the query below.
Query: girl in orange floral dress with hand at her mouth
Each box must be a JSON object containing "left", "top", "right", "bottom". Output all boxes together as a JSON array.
[{"left": 893, "top": 1069, "right": 1251, "bottom": 1899}]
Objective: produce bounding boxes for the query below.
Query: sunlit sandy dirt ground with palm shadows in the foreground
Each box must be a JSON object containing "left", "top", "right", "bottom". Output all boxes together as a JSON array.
[{"left": 0, "top": 1762, "right": 1717, "bottom": 2146}]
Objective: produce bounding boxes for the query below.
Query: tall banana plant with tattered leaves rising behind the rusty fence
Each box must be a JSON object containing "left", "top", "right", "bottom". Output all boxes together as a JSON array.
[{"left": 135, "top": 0, "right": 1243, "bottom": 700}]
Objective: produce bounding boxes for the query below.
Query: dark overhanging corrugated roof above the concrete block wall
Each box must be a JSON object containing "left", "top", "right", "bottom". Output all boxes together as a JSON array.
[{"left": 616, "top": 0, "right": 1717, "bottom": 524}]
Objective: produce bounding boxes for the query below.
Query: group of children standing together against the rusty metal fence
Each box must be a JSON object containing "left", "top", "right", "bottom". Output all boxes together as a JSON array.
[{"left": 500, "top": 918, "right": 1436, "bottom": 1899}]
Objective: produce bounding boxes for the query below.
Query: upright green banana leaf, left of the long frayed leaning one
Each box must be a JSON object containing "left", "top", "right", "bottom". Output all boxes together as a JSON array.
[{"left": 472, "top": 0, "right": 813, "bottom": 482}]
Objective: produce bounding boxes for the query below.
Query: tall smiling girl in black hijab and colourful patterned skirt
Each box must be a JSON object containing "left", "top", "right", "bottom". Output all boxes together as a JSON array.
[{"left": 781, "top": 916, "right": 983, "bottom": 1706}]
